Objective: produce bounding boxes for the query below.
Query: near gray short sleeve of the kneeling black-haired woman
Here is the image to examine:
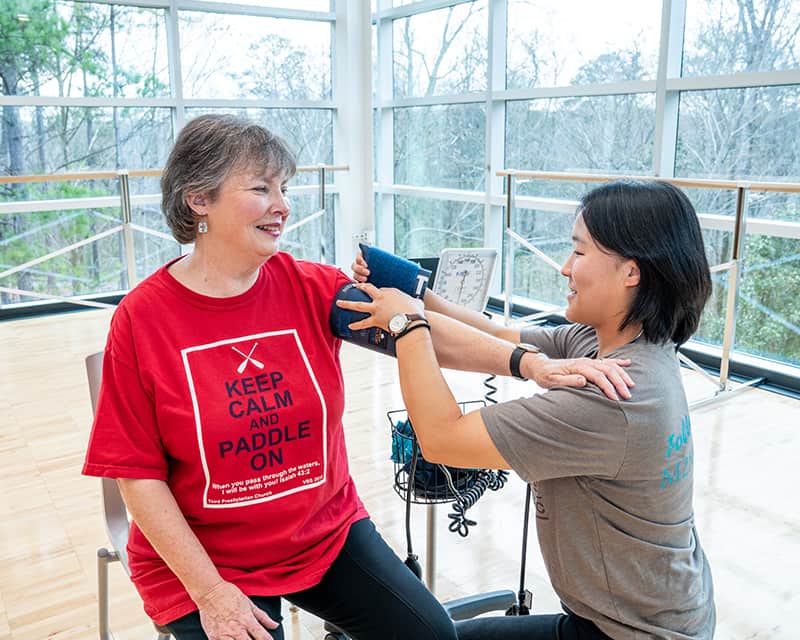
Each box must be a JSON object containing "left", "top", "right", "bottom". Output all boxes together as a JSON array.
[{"left": 481, "top": 387, "right": 627, "bottom": 482}]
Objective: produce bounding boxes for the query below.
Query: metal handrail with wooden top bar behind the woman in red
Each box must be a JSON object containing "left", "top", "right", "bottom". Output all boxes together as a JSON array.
[{"left": 0, "top": 164, "right": 349, "bottom": 307}]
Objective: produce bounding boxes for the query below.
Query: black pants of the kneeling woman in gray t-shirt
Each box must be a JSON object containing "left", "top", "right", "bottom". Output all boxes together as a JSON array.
[{"left": 456, "top": 607, "right": 613, "bottom": 640}]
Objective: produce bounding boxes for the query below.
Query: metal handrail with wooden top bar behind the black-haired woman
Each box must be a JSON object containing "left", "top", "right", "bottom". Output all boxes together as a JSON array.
[{"left": 497, "top": 169, "right": 800, "bottom": 408}]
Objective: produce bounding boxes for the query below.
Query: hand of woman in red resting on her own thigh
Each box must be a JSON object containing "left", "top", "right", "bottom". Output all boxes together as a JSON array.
[{"left": 196, "top": 581, "right": 279, "bottom": 640}]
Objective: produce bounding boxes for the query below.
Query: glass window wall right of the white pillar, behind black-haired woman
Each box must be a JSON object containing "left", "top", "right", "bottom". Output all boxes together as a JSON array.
[{"left": 374, "top": 0, "right": 800, "bottom": 376}]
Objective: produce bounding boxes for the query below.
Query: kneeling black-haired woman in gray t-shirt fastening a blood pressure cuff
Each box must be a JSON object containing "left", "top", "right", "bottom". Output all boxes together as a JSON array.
[{"left": 338, "top": 182, "right": 715, "bottom": 640}]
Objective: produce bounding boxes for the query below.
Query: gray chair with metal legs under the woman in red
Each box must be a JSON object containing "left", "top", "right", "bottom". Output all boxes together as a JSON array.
[{"left": 86, "top": 351, "right": 172, "bottom": 640}]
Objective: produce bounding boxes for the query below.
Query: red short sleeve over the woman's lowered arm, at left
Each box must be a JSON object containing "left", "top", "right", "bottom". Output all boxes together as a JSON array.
[{"left": 83, "top": 309, "right": 167, "bottom": 480}]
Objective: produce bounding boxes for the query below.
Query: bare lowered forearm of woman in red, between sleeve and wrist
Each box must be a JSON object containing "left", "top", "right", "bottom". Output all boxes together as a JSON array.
[{"left": 117, "top": 478, "right": 222, "bottom": 602}]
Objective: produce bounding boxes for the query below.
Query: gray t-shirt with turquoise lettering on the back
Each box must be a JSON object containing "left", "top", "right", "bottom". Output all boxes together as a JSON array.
[{"left": 481, "top": 325, "right": 716, "bottom": 640}]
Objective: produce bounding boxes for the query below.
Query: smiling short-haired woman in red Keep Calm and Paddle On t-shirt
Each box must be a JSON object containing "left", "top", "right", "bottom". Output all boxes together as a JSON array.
[{"left": 84, "top": 115, "right": 455, "bottom": 640}]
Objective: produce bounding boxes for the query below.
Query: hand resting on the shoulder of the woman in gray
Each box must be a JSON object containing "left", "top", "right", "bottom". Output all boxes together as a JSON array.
[{"left": 520, "top": 355, "right": 634, "bottom": 400}]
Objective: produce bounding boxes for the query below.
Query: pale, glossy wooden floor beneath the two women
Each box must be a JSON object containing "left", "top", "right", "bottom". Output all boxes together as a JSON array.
[{"left": 0, "top": 311, "right": 800, "bottom": 640}]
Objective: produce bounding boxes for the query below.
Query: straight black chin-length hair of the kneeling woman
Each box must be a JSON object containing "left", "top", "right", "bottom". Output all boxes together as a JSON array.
[{"left": 580, "top": 181, "right": 711, "bottom": 345}]
